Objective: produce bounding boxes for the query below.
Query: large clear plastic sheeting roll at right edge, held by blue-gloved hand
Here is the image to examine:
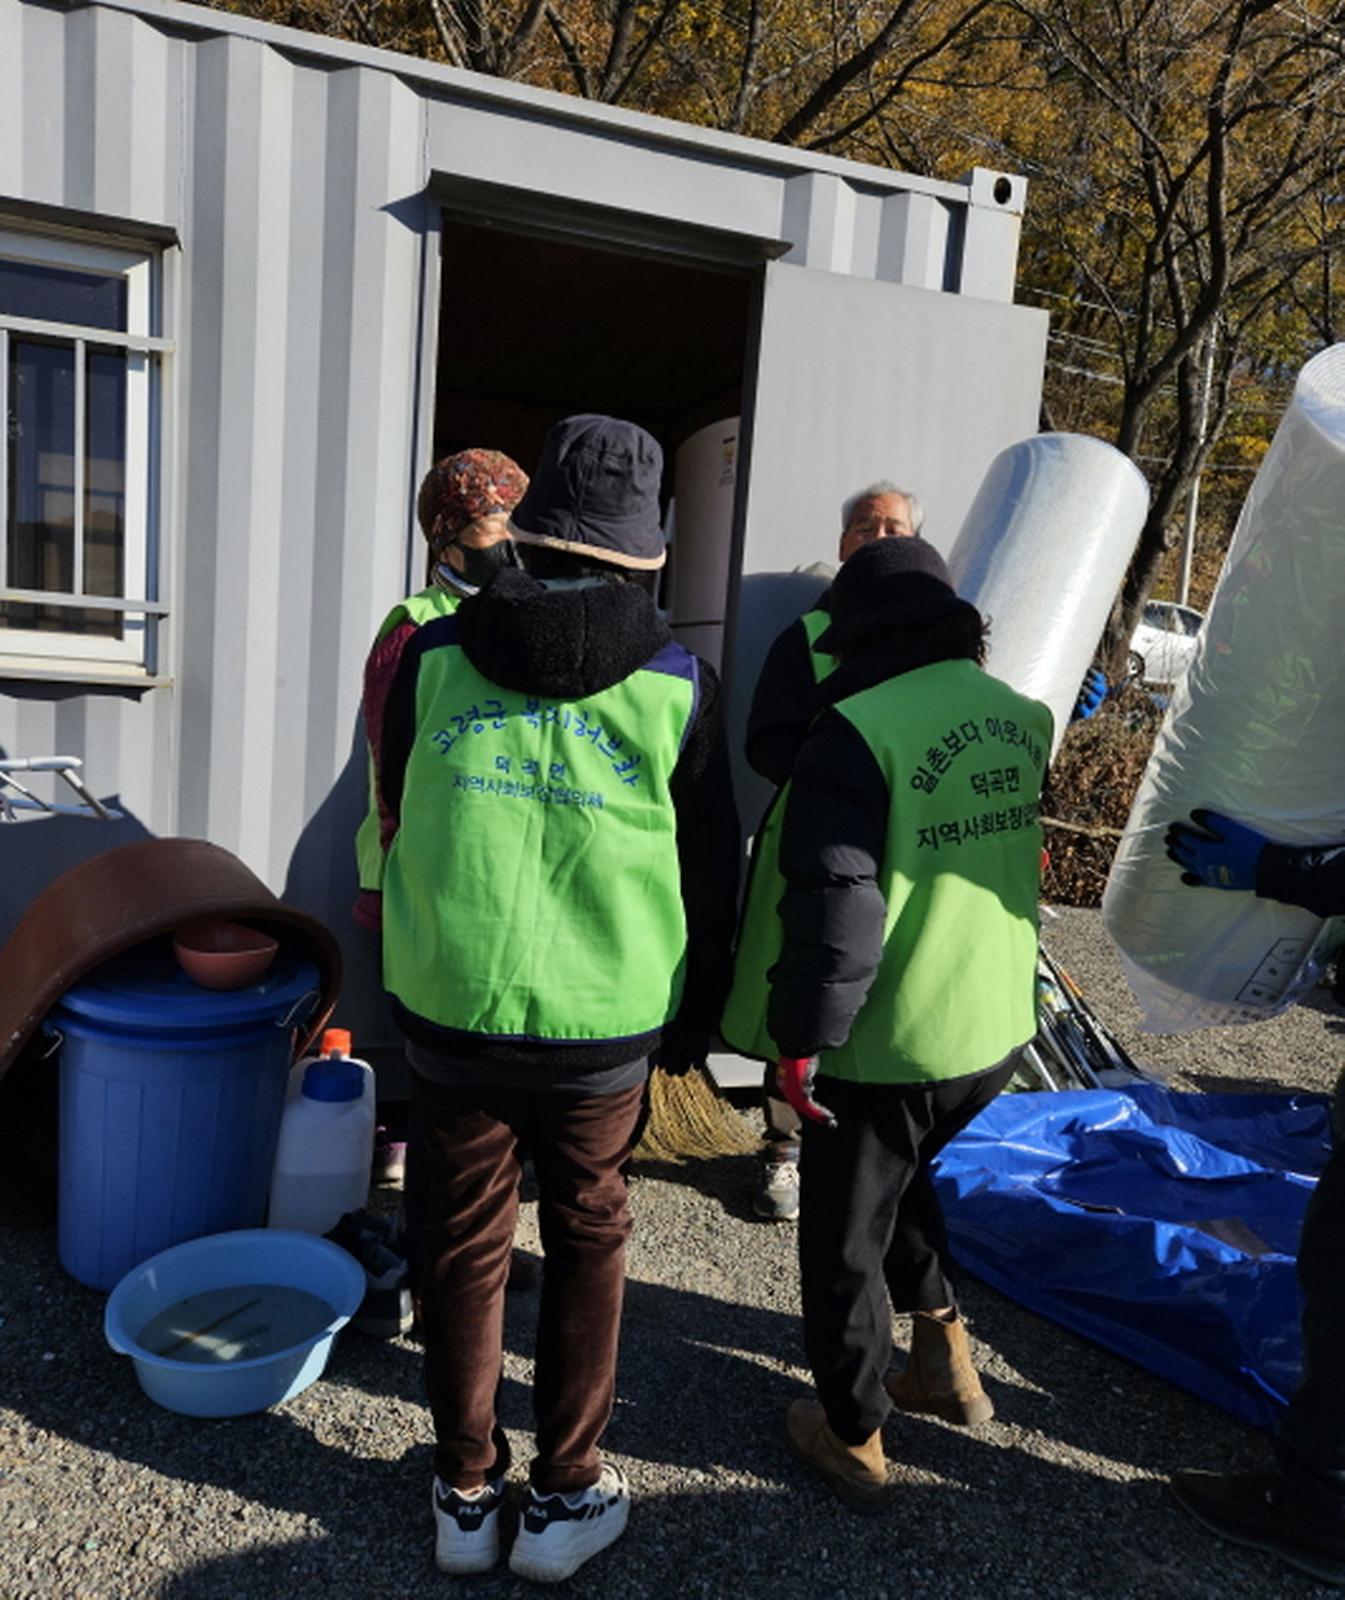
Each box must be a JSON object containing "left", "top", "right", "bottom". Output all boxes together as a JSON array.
[{"left": 1102, "top": 344, "right": 1345, "bottom": 1034}]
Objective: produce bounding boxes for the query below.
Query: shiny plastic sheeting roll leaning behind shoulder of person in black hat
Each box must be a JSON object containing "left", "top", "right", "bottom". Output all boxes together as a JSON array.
[{"left": 948, "top": 434, "right": 1148, "bottom": 746}]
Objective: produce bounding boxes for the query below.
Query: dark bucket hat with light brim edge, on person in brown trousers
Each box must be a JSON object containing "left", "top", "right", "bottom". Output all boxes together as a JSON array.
[{"left": 509, "top": 413, "right": 667, "bottom": 571}]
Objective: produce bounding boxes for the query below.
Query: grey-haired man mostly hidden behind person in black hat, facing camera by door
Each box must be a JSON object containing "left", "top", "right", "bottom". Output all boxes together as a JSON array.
[{"left": 735, "top": 478, "right": 924, "bottom": 1222}]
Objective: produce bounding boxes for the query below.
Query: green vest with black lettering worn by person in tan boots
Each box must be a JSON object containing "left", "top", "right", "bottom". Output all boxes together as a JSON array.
[{"left": 721, "top": 661, "right": 1052, "bottom": 1083}]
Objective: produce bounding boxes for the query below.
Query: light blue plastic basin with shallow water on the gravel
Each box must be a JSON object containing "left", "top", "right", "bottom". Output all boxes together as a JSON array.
[{"left": 102, "top": 1227, "right": 366, "bottom": 1416}]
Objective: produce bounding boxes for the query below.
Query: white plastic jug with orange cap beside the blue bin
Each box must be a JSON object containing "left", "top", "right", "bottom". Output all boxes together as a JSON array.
[{"left": 267, "top": 1027, "right": 376, "bottom": 1234}]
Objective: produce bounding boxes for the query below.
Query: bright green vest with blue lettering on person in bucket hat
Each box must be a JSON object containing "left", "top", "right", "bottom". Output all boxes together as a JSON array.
[{"left": 382, "top": 630, "right": 696, "bottom": 1042}]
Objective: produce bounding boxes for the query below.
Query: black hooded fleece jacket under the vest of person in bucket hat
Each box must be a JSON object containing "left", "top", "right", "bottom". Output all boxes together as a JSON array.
[{"left": 379, "top": 568, "right": 739, "bottom": 1074}]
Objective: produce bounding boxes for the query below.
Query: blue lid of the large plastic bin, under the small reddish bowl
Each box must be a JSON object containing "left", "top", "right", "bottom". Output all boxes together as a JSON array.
[{"left": 56, "top": 939, "right": 321, "bottom": 1034}]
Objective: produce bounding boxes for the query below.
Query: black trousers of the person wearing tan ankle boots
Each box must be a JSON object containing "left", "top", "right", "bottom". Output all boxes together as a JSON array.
[{"left": 798, "top": 1061, "right": 1014, "bottom": 1445}]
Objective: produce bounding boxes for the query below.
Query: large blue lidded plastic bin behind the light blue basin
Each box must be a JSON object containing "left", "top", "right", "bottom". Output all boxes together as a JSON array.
[{"left": 48, "top": 941, "right": 320, "bottom": 1290}]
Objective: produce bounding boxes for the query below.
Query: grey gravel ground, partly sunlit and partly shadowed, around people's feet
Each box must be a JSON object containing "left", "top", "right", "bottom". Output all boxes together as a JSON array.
[{"left": 0, "top": 910, "right": 1345, "bottom": 1600}]
